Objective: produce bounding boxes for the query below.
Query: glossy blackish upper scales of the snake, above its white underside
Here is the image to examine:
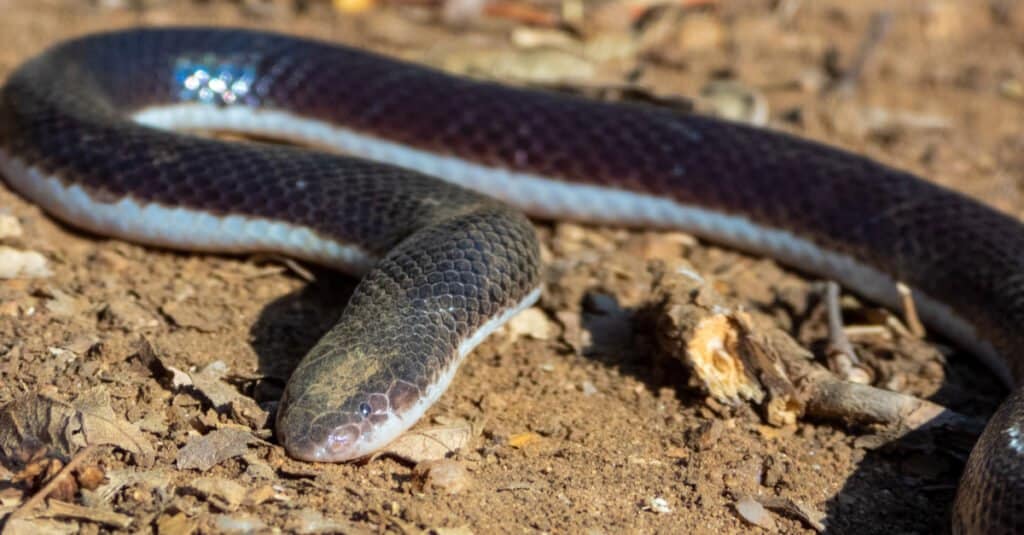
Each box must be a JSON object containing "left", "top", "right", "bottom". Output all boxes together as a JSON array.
[{"left": 0, "top": 29, "right": 1024, "bottom": 533}]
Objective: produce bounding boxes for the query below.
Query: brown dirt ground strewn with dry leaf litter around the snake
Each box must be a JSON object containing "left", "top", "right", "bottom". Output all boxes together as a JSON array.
[{"left": 0, "top": 0, "right": 1024, "bottom": 534}]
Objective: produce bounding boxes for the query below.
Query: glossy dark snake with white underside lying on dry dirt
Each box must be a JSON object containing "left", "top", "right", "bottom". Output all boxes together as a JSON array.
[{"left": 0, "top": 27, "right": 1024, "bottom": 533}]
